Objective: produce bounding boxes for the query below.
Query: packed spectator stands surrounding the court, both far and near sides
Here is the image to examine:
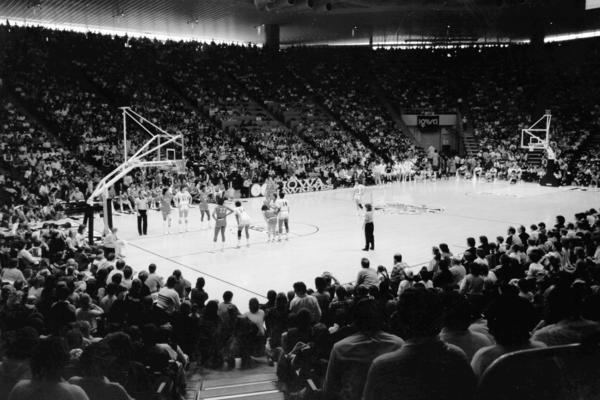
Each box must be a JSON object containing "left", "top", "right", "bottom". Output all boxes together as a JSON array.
[{"left": 0, "top": 26, "right": 600, "bottom": 400}]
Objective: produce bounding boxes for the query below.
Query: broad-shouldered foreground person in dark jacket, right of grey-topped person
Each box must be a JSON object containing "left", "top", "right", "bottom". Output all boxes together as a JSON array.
[{"left": 363, "top": 288, "right": 476, "bottom": 400}]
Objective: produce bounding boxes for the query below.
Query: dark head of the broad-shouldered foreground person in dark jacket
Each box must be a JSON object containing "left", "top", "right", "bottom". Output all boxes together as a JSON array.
[{"left": 398, "top": 288, "right": 443, "bottom": 339}]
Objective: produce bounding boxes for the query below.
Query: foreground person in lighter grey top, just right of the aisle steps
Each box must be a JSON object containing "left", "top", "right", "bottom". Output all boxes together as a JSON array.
[{"left": 323, "top": 299, "right": 404, "bottom": 400}]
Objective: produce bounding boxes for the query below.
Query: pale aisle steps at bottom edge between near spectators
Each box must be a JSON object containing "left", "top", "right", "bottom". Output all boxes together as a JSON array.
[{"left": 186, "top": 362, "right": 284, "bottom": 400}]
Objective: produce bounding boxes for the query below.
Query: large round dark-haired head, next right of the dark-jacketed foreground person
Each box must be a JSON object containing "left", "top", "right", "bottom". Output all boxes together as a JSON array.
[{"left": 486, "top": 293, "right": 536, "bottom": 346}]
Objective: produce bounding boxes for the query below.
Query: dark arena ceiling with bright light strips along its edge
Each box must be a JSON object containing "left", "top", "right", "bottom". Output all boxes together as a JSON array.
[{"left": 0, "top": 0, "right": 600, "bottom": 44}]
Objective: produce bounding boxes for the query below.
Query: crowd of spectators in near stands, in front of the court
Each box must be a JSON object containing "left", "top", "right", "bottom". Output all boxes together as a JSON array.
[{"left": 0, "top": 191, "right": 600, "bottom": 400}]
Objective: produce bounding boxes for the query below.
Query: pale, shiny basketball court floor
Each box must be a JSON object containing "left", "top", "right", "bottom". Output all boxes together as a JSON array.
[{"left": 95, "top": 179, "right": 600, "bottom": 310}]
